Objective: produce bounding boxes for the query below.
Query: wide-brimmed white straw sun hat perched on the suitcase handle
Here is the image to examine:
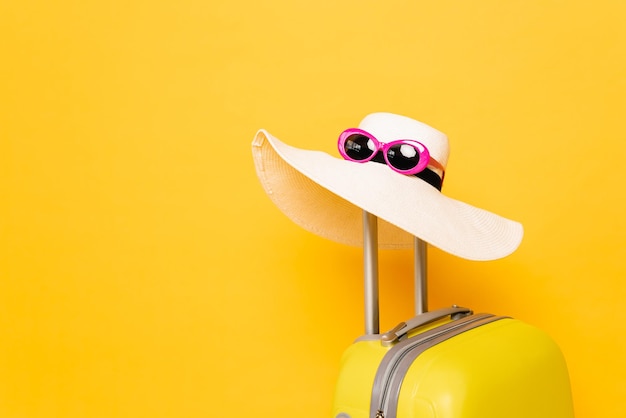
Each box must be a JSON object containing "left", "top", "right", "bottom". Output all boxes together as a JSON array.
[{"left": 252, "top": 113, "right": 523, "bottom": 260}]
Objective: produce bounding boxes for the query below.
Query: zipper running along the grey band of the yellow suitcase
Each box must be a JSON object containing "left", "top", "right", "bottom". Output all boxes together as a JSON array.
[{"left": 374, "top": 314, "right": 494, "bottom": 418}]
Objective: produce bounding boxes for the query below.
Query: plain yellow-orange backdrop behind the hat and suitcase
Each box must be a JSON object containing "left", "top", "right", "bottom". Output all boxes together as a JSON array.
[{"left": 0, "top": 0, "right": 626, "bottom": 418}]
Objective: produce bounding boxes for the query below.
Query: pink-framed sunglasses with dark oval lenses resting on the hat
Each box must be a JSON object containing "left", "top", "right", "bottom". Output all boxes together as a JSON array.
[{"left": 337, "top": 128, "right": 436, "bottom": 175}]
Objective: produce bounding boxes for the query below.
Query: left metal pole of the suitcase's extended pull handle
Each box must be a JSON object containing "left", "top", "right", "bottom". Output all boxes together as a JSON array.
[{"left": 363, "top": 210, "right": 380, "bottom": 335}]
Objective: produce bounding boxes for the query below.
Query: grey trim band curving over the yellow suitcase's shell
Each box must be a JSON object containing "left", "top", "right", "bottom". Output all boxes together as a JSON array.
[{"left": 370, "top": 314, "right": 505, "bottom": 418}]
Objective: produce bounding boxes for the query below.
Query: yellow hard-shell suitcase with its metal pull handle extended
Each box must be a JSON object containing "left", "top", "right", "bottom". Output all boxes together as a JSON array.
[{"left": 332, "top": 214, "right": 574, "bottom": 418}]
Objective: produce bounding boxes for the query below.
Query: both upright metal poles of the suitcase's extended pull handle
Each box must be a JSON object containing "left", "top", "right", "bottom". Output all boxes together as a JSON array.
[{"left": 363, "top": 210, "right": 428, "bottom": 335}]
